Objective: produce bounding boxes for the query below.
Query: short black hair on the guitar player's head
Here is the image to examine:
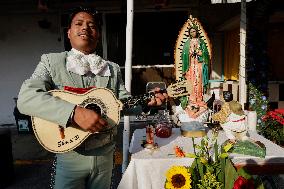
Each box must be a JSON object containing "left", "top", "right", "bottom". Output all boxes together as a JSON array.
[{"left": 68, "top": 6, "right": 101, "bottom": 30}]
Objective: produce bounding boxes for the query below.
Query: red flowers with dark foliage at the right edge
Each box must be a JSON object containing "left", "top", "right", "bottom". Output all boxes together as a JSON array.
[{"left": 261, "top": 109, "right": 284, "bottom": 145}]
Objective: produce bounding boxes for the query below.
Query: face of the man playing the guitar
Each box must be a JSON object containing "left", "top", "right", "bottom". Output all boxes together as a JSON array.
[{"left": 68, "top": 12, "right": 99, "bottom": 54}]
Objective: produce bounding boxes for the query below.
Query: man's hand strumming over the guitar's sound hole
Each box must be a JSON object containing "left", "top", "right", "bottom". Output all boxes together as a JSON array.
[{"left": 73, "top": 106, "right": 108, "bottom": 133}]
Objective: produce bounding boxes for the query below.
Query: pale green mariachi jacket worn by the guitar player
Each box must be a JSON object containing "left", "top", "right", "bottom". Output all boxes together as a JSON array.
[{"left": 17, "top": 52, "right": 129, "bottom": 126}]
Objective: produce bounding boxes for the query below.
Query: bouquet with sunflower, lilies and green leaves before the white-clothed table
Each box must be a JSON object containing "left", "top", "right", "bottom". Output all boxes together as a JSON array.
[{"left": 165, "top": 133, "right": 264, "bottom": 189}]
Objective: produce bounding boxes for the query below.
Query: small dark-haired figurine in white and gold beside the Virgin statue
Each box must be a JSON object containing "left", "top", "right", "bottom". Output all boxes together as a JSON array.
[{"left": 212, "top": 91, "right": 248, "bottom": 143}]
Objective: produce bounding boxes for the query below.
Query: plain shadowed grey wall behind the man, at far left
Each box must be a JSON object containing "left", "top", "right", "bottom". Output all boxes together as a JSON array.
[{"left": 0, "top": 14, "right": 64, "bottom": 125}]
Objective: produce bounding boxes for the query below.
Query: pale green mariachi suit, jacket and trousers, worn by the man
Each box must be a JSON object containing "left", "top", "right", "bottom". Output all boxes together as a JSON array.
[{"left": 17, "top": 51, "right": 137, "bottom": 189}]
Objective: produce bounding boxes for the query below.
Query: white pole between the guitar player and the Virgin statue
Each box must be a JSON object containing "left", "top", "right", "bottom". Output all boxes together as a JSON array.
[{"left": 122, "top": 0, "right": 134, "bottom": 173}]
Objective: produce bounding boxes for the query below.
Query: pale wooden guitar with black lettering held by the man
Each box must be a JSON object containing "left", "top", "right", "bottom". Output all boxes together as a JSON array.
[{"left": 31, "top": 80, "right": 192, "bottom": 153}]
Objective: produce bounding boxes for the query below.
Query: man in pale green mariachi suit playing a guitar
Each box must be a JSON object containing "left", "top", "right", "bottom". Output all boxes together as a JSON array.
[{"left": 18, "top": 8, "right": 167, "bottom": 189}]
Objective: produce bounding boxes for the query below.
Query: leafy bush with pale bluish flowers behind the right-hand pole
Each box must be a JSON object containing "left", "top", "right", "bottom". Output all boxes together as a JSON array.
[{"left": 248, "top": 83, "right": 268, "bottom": 131}]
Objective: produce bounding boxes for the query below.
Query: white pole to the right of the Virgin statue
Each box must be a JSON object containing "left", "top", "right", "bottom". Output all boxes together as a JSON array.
[{"left": 239, "top": 0, "right": 247, "bottom": 108}]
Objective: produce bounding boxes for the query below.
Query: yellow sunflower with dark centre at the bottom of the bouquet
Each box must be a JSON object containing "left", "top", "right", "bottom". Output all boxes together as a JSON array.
[{"left": 165, "top": 166, "right": 191, "bottom": 189}]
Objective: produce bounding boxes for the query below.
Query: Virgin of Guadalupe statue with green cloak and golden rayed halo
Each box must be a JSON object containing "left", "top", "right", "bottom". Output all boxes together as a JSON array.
[{"left": 174, "top": 16, "right": 212, "bottom": 117}]
